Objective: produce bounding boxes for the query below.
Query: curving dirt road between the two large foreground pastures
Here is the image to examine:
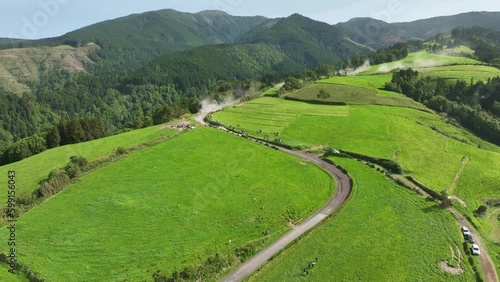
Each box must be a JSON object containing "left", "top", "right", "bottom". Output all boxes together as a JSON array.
[{"left": 222, "top": 144, "right": 352, "bottom": 282}]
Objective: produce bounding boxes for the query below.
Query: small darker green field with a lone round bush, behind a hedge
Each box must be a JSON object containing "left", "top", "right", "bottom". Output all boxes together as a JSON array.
[{"left": 288, "top": 82, "right": 423, "bottom": 108}]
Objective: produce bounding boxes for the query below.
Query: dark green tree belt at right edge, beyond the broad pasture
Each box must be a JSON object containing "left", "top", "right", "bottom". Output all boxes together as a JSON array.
[{"left": 386, "top": 68, "right": 500, "bottom": 145}]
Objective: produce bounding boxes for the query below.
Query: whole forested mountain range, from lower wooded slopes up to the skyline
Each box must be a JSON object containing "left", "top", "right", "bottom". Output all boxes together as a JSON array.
[{"left": 0, "top": 7, "right": 500, "bottom": 145}]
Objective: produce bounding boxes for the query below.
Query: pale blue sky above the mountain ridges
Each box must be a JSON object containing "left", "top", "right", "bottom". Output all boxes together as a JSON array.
[{"left": 0, "top": 0, "right": 500, "bottom": 39}]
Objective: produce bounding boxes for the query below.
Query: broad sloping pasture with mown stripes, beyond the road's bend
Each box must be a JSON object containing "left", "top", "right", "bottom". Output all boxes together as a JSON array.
[{"left": 213, "top": 98, "right": 500, "bottom": 208}]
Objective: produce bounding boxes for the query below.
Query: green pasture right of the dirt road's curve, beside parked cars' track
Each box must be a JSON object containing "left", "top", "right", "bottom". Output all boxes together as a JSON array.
[{"left": 248, "top": 158, "right": 475, "bottom": 281}]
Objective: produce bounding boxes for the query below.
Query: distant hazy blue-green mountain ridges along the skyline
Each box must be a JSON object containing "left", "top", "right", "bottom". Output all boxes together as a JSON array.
[{"left": 0, "top": 9, "right": 500, "bottom": 67}]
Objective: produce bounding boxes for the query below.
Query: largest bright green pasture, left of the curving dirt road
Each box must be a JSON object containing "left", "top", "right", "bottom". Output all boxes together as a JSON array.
[{"left": 0, "top": 128, "right": 335, "bottom": 281}]
